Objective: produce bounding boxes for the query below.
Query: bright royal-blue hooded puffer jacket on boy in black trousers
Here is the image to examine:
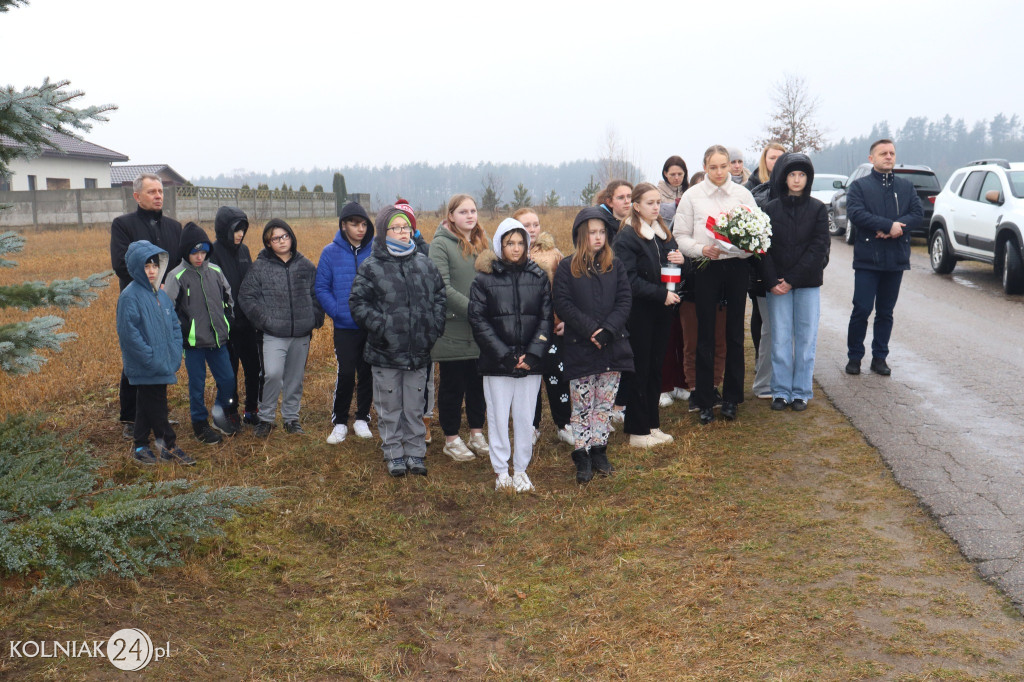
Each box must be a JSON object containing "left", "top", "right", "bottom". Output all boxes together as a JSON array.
[{"left": 316, "top": 202, "right": 374, "bottom": 329}]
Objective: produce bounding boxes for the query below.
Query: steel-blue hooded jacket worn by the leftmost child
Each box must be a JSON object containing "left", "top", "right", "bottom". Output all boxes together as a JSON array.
[{"left": 117, "top": 240, "right": 181, "bottom": 386}]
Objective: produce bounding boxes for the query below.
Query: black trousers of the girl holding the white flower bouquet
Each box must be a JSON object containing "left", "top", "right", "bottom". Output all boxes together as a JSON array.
[{"left": 694, "top": 258, "right": 750, "bottom": 408}]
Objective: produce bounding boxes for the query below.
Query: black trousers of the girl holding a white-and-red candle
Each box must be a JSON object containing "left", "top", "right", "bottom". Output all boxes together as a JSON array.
[{"left": 624, "top": 302, "right": 671, "bottom": 435}]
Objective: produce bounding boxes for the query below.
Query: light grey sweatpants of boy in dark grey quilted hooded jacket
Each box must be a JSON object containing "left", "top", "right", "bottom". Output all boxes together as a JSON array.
[{"left": 259, "top": 334, "right": 309, "bottom": 424}]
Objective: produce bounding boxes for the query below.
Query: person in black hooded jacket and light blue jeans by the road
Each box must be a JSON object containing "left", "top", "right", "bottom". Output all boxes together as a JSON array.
[{"left": 758, "top": 154, "right": 829, "bottom": 412}]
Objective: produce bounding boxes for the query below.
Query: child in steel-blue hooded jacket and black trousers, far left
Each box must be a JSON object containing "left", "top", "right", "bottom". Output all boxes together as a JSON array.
[{"left": 117, "top": 240, "right": 196, "bottom": 466}]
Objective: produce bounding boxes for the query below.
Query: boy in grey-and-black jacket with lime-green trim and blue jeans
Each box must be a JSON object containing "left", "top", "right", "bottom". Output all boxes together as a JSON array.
[{"left": 164, "top": 222, "right": 242, "bottom": 443}]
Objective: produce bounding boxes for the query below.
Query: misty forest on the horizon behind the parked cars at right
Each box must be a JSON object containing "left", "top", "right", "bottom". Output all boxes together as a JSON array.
[{"left": 813, "top": 114, "right": 1024, "bottom": 182}]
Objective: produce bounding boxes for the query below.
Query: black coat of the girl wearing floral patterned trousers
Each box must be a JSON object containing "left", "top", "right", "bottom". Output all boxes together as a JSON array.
[{"left": 553, "top": 257, "right": 633, "bottom": 379}]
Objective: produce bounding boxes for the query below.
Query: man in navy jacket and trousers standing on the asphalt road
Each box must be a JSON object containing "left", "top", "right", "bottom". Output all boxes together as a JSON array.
[{"left": 846, "top": 139, "right": 925, "bottom": 376}]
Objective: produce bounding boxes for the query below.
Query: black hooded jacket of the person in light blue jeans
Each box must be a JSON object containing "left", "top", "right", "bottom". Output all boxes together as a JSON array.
[{"left": 757, "top": 154, "right": 830, "bottom": 289}]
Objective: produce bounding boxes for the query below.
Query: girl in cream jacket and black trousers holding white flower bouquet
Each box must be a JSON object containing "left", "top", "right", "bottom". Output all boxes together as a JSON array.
[{"left": 673, "top": 144, "right": 755, "bottom": 424}]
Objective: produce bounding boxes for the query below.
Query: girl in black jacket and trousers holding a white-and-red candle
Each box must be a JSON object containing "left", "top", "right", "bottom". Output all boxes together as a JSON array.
[{"left": 613, "top": 182, "right": 683, "bottom": 447}]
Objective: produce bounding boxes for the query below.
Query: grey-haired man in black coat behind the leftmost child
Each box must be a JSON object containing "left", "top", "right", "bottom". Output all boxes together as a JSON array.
[{"left": 111, "top": 173, "right": 181, "bottom": 438}]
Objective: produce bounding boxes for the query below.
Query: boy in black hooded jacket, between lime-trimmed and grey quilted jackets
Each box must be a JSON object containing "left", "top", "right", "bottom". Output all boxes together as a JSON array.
[{"left": 210, "top": 206, "right": 259, "bottom": 426}]
